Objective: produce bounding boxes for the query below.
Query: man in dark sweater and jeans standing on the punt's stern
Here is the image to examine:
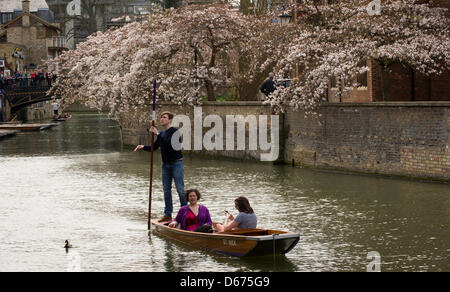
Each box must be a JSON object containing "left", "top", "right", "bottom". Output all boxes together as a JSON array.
[{"left": 134, "top": 112, "right": 187, "bottom": 222}]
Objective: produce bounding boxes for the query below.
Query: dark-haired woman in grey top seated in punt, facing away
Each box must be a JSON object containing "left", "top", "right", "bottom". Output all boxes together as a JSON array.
[{"left": 216, "top": 197, "right": 258, "bottom": 232}]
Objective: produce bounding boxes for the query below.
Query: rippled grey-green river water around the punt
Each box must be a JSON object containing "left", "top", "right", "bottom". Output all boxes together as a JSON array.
[{"left": 0, "top": 113, "right": 450, "bottom": 272}]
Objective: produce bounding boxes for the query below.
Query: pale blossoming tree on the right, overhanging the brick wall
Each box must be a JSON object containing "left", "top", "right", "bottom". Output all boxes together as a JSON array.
[{"left": 268, "top": 0, "right": 450, "bottom": 115}]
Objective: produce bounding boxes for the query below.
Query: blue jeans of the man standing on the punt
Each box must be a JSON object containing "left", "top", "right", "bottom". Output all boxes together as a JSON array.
[{"left": 162, "top": 161, "right": 187, "bottom": 216}]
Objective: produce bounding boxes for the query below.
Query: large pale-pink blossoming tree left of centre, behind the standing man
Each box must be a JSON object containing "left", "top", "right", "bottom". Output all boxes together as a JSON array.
[{"left": 46, "top": 5, "right": 275, "bottom": 121}]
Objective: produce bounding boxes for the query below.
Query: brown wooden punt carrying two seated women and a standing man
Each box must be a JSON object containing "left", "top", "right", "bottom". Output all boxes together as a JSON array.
[{"left": 152, "top": 220, "right": 300, "bottom": 257}]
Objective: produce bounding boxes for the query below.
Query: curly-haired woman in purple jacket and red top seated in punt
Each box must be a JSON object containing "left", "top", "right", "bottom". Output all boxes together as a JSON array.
[{"left": 169, "top": 189, "right": 212, "bottom": 231}]
